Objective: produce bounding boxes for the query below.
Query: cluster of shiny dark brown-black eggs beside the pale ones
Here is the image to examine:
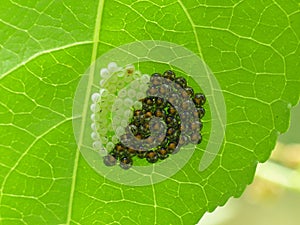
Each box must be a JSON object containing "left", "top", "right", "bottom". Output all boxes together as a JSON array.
[{"left": 103, "top": 70, "right": 206, "bottom": 169}]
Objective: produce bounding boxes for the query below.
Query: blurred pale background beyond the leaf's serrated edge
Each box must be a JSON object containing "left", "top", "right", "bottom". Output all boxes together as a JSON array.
[{"left": 198, "top": 104, "right": 300, "bottom": 225}]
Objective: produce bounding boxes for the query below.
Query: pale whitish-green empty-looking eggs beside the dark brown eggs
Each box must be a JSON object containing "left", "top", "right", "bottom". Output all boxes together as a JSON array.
[{"left": 90, "top": 62, "right": 150, "bottom": 155}]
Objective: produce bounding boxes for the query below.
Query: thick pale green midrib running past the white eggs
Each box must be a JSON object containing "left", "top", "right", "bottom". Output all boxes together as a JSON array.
[{"left": 66, "top": 0, "right": 104, "bottom": 224}]
